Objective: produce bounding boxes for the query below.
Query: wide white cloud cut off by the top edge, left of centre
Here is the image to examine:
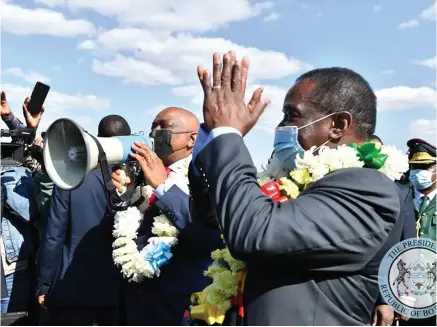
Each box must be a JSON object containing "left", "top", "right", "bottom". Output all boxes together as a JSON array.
[{"left": 58, "top": 0, "right": 273, "bottom": 32}]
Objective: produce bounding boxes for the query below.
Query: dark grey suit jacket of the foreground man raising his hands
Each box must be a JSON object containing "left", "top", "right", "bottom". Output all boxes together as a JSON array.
[{"left": 190, "top": 134, "right": 403, "bottom": 326}]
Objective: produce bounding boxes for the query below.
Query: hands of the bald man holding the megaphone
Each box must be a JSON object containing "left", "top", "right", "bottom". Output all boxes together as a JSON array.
[{"left": 111, "top": 141, "right": 167, "bottom": 193}]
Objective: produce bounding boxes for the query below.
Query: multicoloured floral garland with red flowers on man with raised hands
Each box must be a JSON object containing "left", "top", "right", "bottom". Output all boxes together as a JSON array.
[{"left": 191, "top": 142, "right": 409, "bottom": 325}]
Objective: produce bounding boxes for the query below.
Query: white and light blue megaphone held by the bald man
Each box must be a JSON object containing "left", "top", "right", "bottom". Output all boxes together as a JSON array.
[{"left": 43, "top": 118, "right": 150, "bottom": 190}]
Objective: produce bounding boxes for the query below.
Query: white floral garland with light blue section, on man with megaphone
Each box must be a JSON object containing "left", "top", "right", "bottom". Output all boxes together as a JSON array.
[{"left": 112, "top": 157, "right": 191, "bottom": 283}]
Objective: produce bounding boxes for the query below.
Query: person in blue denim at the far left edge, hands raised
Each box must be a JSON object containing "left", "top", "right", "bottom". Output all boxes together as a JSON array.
[{"left": 0, "top": 92, "right": 44, "bottom": 319}]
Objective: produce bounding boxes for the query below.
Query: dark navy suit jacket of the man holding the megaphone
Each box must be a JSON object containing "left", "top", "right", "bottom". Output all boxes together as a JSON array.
[{"left": 122, "top": 185, "right": 224, "bottom": 326}]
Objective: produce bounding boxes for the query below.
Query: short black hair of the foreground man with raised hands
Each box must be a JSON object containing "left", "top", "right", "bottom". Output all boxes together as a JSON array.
[{"left": 296, "top": 67, "right": 376, "bottom": 140}]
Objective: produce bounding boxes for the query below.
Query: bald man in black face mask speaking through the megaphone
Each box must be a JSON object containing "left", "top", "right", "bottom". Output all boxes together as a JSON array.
[{"left": 112, "top": 107, "right": 223, "bottom": 326}]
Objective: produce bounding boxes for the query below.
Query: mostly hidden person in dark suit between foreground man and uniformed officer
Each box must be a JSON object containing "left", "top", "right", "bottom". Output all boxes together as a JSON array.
[{"left": 370, "top": 135, "right": 416, "bottom": 326}]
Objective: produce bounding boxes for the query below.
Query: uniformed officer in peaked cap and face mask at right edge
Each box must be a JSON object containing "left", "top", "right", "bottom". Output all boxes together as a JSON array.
[{"left": 407, "top": 139, "right": 437, "bottom": 241}]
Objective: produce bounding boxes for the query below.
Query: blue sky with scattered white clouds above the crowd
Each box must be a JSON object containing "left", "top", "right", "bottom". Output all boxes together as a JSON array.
[{"left": 0, "top": 0, "right": 436, "bottom": 167}]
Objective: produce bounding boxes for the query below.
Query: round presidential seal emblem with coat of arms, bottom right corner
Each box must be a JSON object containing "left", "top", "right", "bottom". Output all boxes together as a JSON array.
[{"left": 378, "top": 238, "right": 437, "bottom": 319}]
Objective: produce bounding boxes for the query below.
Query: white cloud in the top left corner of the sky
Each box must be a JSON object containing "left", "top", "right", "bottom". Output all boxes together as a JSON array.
[{"left": 0, "top": 0, "right": 95, "bottom": 37}]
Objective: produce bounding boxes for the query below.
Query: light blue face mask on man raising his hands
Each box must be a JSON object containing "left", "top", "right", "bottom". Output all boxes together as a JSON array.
[{"left": 273, "top": 112, "right": 335, "bottom": 170}]
